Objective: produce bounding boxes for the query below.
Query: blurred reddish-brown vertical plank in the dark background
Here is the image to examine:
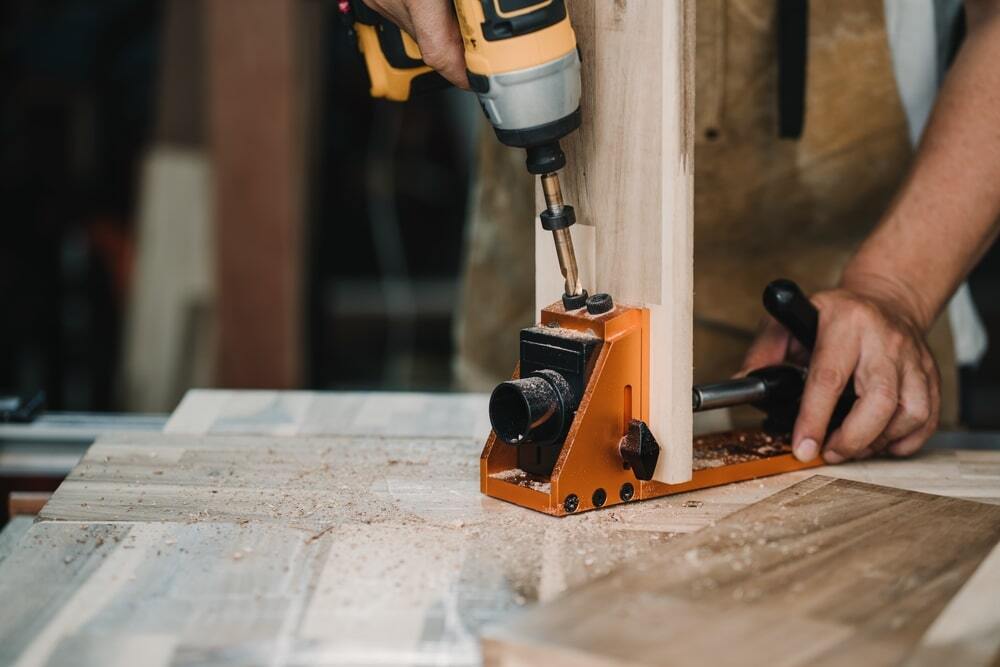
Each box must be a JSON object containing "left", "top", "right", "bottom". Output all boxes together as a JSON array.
[{"left": 205, "top": 0, "right": 305, "bottom": 388}]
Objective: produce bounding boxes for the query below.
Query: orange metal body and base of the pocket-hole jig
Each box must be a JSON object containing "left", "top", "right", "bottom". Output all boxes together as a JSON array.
[{"left": 480, "top": 303, "right": 821, "bottom": 516}]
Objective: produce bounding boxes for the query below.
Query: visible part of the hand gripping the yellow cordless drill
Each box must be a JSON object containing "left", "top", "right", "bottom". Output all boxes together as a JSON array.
[{"left": 409, "top": 0, "right": 469, "bottom": 88}]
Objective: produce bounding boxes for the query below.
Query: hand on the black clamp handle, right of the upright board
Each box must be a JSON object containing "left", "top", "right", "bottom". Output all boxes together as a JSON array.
[{"left": 743, "top": 289, "right": 941, "bottom": 463}]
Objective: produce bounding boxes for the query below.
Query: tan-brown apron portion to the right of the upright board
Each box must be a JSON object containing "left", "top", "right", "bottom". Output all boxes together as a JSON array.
[{"left": 694, "top": 0, "right": 957, "bottom": 423}]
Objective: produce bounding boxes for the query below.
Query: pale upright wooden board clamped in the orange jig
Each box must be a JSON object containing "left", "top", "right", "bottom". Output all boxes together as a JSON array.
[{"left": 535, "top": 0, "right": 694, "bottom": 483}]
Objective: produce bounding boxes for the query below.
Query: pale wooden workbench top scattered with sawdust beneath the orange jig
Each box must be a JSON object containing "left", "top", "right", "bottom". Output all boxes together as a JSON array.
[{"left": 0, "top": 392, "right": 1000, "bottom": 666}]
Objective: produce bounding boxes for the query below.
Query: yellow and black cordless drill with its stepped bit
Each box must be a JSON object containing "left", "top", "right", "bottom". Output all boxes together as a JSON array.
[{"left": 348, "top": 0, "right": 587, "bottom": 310}]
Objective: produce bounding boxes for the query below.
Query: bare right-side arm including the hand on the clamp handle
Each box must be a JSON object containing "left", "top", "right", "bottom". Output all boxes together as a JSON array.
[{"left": 744, "top": 0, "right": 1000, "bottom": 463}]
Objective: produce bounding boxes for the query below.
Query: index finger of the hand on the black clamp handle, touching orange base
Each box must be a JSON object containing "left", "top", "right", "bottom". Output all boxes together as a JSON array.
[{"left": 792, "top": 315, "right": 860, "bottom": 460}]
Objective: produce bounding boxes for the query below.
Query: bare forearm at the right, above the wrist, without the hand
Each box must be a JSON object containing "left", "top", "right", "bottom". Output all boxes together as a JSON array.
[{"left": 842, "top": 0, "right": 1000, "bottom": 330}]
